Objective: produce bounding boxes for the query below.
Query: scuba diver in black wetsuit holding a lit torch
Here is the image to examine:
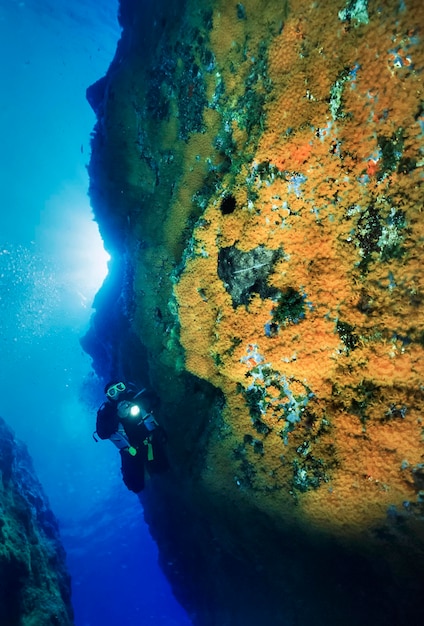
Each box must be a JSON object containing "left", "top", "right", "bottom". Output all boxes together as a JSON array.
[{"left": 96, "top": 381, "right": 168, "bottom": 493}]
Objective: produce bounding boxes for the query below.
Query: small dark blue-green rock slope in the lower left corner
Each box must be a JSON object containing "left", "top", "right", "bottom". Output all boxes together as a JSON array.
[{"left": 0, "top": 418, "right": 73, "bottom": 626}]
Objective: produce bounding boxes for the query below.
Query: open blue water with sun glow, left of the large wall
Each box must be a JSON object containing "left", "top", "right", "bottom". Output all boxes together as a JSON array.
[{"left": 0, "top": 0, "right": 190, "bottom": 626}]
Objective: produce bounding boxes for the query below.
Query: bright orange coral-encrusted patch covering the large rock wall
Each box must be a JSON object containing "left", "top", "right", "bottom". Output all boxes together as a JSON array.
[{"left": 175, "top": 0, "right": 424, "bottom": 537}]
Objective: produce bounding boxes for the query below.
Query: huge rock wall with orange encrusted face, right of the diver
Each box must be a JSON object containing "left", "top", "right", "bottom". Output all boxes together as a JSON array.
[{"left": 86, "top": 0, "right": 424, "bottom": 626}]
